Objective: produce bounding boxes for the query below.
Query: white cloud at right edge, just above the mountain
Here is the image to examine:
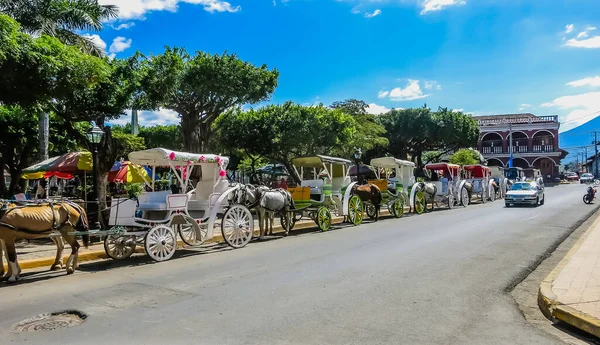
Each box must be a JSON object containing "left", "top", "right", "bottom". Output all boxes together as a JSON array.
[{"left": 541, "top": 92, "right": 600, "bottom": 132}]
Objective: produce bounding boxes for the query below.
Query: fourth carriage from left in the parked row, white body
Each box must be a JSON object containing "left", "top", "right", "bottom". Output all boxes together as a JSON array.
[{"left": 410, "top": 163, "right": 470, "bottom": 214}]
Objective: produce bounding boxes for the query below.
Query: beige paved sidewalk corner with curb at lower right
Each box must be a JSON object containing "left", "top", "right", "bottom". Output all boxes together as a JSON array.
[{"left": 538, "top": 211, "right": 600, "bottom": 337}]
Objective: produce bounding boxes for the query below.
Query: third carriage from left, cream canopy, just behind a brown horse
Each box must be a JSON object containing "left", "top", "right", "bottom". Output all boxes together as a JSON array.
[{"left": 367, "top": 157, "right": 415, "bottom": 218}]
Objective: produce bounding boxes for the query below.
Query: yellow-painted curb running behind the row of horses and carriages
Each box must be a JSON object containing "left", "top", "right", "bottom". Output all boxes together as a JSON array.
[{"left": 4, "top": 208, "right": 407, "bottom": 272}]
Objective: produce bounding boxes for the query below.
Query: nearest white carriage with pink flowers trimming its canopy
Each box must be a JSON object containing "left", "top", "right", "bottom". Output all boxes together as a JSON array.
[{"left": 104, "top": 148, "right": 254, "bottom": 261}]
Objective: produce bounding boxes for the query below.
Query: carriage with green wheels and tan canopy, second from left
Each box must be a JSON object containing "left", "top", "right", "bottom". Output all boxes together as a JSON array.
[{"left": 288, "top": 155, "right": 365, "bottom": 231}]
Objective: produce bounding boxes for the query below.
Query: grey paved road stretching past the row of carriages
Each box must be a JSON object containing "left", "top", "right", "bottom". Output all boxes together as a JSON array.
[{"left": 0, "top": 185, "right": 593, "bottom": 345}]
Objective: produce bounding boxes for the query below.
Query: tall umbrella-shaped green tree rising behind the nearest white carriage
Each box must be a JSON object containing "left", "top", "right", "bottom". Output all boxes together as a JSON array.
[{"left": 142, "top": 47, "right": 279, "bottom": 152}]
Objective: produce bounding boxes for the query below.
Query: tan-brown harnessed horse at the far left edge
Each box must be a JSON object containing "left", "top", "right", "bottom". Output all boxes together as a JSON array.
[{"left": 0, "top": 202, "right": 89, "bottom": 282}]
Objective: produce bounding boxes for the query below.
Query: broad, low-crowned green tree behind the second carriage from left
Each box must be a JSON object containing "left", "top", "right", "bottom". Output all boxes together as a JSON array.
[{"left": 215, "top": 102, "right": 356, "bottom": 182}]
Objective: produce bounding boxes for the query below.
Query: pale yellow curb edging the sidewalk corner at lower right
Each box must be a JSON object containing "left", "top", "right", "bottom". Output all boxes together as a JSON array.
[{"left": 538, "top": 210, "right": 600, "bottom": 337}]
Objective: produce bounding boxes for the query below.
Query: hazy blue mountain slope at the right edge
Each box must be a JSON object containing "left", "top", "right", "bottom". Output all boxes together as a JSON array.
[{"left": 558, "top": 116, "right": 600, "bottom": 164}]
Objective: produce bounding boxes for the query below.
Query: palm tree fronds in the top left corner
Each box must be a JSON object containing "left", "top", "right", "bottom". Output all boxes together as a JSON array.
[{"left": 0, "top": 0, "right": 119, "bottom": 56}]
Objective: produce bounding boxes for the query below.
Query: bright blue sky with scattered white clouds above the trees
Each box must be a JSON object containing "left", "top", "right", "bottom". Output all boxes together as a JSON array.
[{"left": 92, "top": 0, "right": 600, "bottom": 130}]
